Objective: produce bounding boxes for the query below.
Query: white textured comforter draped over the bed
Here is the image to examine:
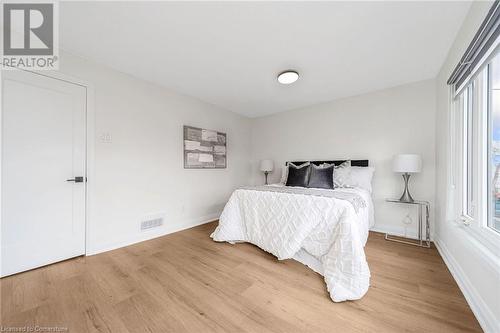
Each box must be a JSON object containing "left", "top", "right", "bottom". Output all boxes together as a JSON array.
[{"left": 211, "top": 184, "right": 373, "bottom": 302}]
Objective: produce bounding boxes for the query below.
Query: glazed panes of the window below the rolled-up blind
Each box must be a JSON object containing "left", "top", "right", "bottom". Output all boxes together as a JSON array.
[{"left": 453, "top": 51, "right": 500, "bottom": 233}]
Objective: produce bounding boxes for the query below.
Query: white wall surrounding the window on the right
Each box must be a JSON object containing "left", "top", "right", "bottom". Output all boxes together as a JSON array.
[{"left": 436, "top": 1, "right": 500, "bottom": 332}]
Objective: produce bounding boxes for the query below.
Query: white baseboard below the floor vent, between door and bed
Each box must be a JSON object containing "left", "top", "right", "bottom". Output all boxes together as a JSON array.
[{"left": 85, "top": 213, "right": 220, "bottom": 256}]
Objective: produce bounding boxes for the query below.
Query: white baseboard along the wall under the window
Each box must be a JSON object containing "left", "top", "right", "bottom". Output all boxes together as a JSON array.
[{"left": 434, "top": 239, "right": 500, "bottom": 333}]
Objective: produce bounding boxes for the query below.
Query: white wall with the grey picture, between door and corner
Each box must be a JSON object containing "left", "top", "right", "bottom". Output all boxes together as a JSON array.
[{"left": 60, "top": 54, "right": 251, "bottom": 253}]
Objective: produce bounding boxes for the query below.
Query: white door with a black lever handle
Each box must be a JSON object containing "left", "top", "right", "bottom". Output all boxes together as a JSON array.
[{"left": 0, "top": 70, "right": 86, "bottom": 276}]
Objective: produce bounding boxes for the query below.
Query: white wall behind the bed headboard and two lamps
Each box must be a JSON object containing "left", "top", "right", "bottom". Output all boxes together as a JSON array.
[{"left": 252, "top": 80, "right": 436, "bottom": 235}]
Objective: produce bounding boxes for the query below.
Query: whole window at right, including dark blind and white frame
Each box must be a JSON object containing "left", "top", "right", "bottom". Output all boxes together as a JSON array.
[{"left": 447, "top": 1, "right": 500, "bottom": 246}]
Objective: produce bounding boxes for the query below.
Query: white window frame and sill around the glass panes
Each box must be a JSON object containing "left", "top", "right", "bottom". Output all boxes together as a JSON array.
[{"left": 449, "top": 42, "right": 500, "bottom": 253}]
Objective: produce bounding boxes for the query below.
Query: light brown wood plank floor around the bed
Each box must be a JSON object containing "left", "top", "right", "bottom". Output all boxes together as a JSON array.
[{"left": 0, "top": 223, "right": 481, "bottom": 333}]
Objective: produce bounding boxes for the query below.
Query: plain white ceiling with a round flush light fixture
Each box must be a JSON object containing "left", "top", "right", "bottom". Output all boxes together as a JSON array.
[{"left": 60, "top": 1, "right": 470, "bottom": 117}]
